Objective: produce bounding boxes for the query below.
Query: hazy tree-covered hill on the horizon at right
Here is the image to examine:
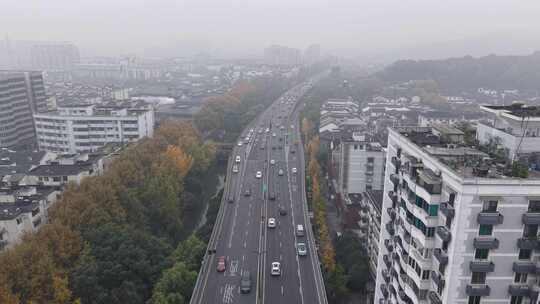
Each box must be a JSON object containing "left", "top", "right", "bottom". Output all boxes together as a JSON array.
[{"left": 376, "top": 51, "right": 540, "bottom": 91}]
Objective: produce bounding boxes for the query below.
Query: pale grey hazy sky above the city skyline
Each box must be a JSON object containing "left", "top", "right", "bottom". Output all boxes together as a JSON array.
[{"left": 0, "top": 0, "right": 540, "bottom": 56}]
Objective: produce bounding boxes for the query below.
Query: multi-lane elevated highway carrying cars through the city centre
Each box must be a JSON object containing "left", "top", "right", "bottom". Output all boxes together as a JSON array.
[{"left": 191, "top": 82, "right": 327, "bottom": 304}]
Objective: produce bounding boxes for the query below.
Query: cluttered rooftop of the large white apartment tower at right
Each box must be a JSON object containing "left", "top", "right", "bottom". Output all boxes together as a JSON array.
[{"left": 390, "top": 125, "right": 540, "bottom": 179}]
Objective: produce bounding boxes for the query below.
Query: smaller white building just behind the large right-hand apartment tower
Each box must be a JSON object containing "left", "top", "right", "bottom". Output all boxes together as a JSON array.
[{"left": 338, "top": 132, "right": 385, "bottom": 194}]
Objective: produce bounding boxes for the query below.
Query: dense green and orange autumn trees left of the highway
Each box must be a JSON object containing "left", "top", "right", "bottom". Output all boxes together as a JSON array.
[{"left": 0, "top": 122, "right": 215, "bottom": 304}]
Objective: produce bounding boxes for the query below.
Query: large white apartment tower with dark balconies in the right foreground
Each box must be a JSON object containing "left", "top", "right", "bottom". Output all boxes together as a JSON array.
[{"left": 375, "top": 123, "right": 540, "bottom": 304}]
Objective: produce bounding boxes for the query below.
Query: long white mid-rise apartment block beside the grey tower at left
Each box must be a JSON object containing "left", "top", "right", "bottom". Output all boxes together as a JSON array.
[{"left": 34, "top": 105, "right": 154, "bottom": 153}]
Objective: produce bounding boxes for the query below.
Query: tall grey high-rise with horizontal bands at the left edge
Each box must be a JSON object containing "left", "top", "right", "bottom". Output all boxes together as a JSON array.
[{"left": 0, "top": 71, "right": 47, "bottom": 147}]
